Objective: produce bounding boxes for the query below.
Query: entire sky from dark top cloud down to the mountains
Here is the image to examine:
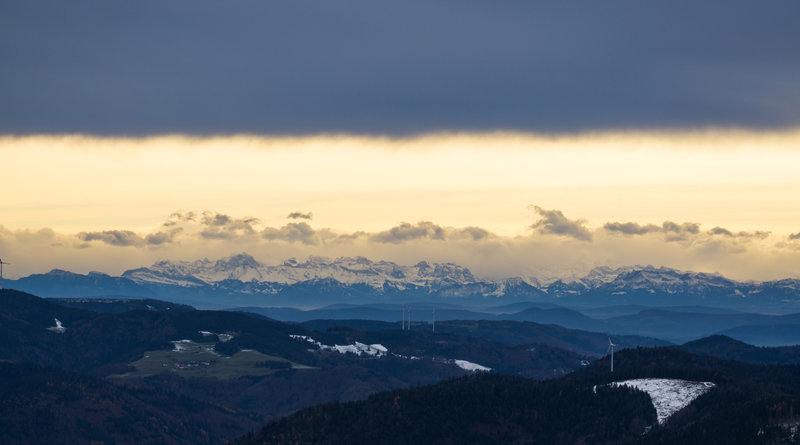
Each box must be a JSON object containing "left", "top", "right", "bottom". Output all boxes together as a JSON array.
[{"left": 0, "top": 0, "right": 800, "bottom": 280}]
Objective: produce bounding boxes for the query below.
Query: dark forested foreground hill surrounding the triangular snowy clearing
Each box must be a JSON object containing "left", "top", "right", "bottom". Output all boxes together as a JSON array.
[{"left": 235, "top": 347, "right": 800, "bottom": 444}]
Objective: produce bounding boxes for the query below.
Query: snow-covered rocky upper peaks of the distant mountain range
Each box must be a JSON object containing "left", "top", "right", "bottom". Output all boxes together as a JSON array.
[{"left": 114, "top": 253, "right": 776, "bottom": 297}]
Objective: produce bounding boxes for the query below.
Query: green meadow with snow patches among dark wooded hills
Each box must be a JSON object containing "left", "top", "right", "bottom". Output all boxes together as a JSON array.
[{"left": 109, "top": 340, "right": 310, "bottom": 379}]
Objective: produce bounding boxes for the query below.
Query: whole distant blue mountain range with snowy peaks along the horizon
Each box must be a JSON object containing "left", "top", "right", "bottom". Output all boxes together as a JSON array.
[{"left": 6, "top": 253, "right": 800, "bottom": 312}]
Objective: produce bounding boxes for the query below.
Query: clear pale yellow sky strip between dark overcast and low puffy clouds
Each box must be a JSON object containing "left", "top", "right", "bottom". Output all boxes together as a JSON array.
[{"left": 0, "top": 131, "right": 800, "bottom": 235}]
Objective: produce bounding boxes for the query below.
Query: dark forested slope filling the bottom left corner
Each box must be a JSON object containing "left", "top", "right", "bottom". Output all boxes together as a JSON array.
[{"left": 0, "top": 362, "right": 258, "bottom": 445}]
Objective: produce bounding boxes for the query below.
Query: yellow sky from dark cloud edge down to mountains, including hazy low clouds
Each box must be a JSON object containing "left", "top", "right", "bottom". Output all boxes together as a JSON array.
[{"left": 0, "top": 130, "right": 800, "bottom": 279}]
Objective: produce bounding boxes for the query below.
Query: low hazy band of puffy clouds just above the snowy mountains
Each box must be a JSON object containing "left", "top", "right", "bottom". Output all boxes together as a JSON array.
[{"left": 0, "top": 206, "right": 800, "bottom": 280}]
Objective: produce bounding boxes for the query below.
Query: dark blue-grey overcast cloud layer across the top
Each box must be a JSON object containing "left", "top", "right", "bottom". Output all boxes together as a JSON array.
[{"left": 0, "top": 0, "right": 800, "bottom": 135}]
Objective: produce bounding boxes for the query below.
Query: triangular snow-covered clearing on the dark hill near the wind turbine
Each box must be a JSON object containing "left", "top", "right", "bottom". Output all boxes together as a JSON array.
[{"left": 610, "top": 379, "right": 716, "bottom": 424}]
